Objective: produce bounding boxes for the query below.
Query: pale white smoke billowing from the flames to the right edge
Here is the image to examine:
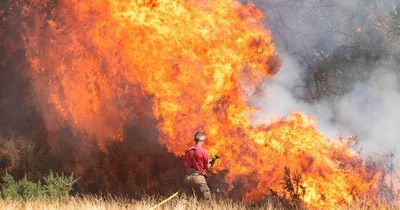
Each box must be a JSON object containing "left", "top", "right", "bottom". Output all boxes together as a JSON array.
[{"left": 251, "top": 54, "right": 400, "bottom": 155}]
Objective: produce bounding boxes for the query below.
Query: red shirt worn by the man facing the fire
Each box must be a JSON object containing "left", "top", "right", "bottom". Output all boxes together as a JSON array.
[{"left": 185, "top": 146, "right": 209, "bottom": 175}]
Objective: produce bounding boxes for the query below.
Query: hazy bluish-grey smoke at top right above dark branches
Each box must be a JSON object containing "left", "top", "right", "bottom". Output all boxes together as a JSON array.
[{"left": 255, "top": 0, "right": 396, "bottom": 57}]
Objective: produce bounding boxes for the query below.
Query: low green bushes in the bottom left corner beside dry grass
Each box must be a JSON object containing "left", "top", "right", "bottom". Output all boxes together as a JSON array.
[{"left": 1, "top": 172, "right": 77, "bottom": 201}]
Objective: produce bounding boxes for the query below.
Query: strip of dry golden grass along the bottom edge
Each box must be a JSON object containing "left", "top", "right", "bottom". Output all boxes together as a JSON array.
[{"left": 0, "top": 196, "right": 400, "bottom": 210}]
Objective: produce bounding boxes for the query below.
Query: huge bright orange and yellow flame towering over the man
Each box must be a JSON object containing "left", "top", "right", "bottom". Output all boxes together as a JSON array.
[{"left": 23, "top": 0, "right": 378, "bottom": 207}]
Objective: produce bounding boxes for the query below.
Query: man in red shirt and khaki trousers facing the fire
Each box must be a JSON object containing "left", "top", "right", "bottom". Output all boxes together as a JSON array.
[{"left": 182, "top": 132, "right": 211, "bottom": 200}]
